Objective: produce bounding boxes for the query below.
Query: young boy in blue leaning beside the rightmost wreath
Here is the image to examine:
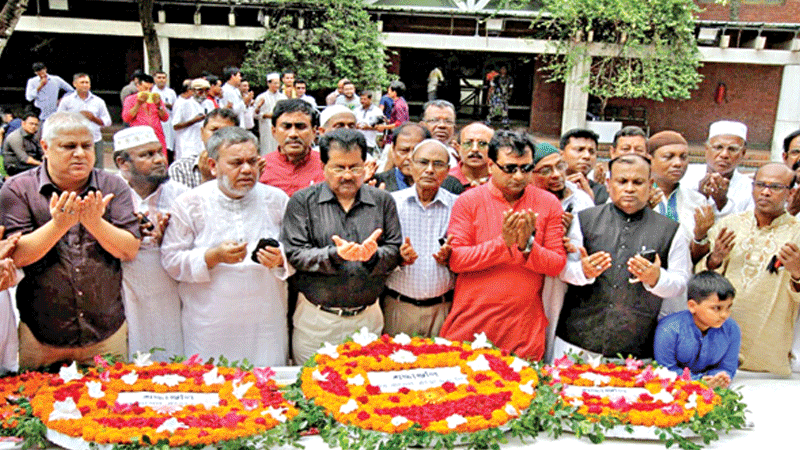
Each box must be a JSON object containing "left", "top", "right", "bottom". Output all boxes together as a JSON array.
[{"left": 654, "top": 271, "right": 742, "bottom": 388}]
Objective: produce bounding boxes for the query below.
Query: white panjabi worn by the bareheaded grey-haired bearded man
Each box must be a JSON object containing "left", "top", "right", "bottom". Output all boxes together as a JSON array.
[{"left": 161, "top": 181, "right": 293, "bottom": 366}]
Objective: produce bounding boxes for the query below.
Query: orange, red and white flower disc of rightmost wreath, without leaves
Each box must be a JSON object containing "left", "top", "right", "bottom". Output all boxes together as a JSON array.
[{"left": 544, "top": 356, "right": 721, "bottom": 428}]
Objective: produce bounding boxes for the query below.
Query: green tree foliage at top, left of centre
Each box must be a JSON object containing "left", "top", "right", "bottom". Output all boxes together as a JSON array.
[{"left": 242, "top": 0, "right": 389, "bottom": 90}]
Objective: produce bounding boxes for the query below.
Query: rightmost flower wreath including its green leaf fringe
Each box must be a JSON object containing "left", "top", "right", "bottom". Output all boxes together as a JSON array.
[{"left": 542, "top": 356, "right": 746, "bottom": 448}]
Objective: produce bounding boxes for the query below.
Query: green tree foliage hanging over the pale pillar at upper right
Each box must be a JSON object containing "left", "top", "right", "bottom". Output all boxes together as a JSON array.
[{"left": 535, "top": 0, "right": 702, "bottom": 113}]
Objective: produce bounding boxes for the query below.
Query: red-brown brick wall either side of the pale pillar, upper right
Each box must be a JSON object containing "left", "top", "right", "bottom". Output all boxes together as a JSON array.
[{"left": 531, "top": 63, "right": 783, "bottom": 148}]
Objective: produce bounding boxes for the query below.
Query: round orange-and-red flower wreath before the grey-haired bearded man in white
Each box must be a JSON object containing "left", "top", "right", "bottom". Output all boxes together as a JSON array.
[{"left": 31, "top": 354, "right": 297, "bottom": 447}]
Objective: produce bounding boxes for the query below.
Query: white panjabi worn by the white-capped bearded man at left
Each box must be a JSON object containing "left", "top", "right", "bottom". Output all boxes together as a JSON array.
[{"left": 122, "top": 180, "right": 189, "bottom": 361}]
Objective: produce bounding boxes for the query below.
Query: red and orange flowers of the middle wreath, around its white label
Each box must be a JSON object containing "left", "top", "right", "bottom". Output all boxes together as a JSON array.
[{"left": 301, "top": 330, "right": 538, "bottom": 434}]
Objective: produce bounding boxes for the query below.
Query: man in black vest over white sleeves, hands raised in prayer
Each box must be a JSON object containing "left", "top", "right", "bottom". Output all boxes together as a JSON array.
[{"left": 554, "top": 155, "right": 691, "bottom": 358}]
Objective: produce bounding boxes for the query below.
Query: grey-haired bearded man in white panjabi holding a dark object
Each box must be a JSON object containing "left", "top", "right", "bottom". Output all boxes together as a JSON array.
[{"left": 161, "top": 127, "right": 293, "bottom": 366}]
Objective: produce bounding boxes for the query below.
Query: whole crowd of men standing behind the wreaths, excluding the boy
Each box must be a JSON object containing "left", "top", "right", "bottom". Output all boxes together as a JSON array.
[{"left": 0, "top": 62, "right": 800, "bottom": 375}]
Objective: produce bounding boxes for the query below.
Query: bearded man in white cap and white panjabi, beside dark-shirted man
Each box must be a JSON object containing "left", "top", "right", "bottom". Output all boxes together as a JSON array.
[{"left": 114, "top": 125, "right": 189, "bottom": 361}]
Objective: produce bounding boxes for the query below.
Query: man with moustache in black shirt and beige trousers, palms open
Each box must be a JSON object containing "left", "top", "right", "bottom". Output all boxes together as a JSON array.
[{"left": 281, "top": 128, "right": 402, "bottom": 364}]
